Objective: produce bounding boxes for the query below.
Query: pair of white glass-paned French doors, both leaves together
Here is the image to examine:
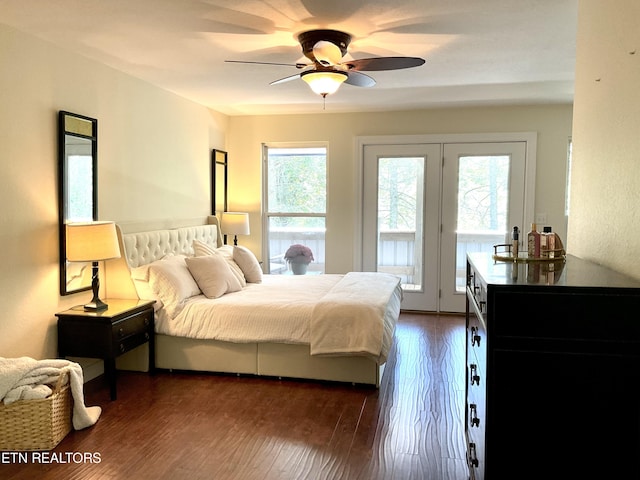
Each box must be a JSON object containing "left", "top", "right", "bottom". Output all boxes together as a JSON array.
[{"left": 361, "top": 134, "right": 535, "bottom": 312}]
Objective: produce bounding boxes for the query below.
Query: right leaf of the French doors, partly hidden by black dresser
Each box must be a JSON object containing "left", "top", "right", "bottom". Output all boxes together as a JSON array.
[{"left": 439, "top": 142, "right": 533, "bottom": 312}]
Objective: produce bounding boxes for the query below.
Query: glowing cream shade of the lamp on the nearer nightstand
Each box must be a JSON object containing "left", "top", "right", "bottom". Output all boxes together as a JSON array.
[{"left": 66, "top": 222, "right": 120, "bottom": 262}]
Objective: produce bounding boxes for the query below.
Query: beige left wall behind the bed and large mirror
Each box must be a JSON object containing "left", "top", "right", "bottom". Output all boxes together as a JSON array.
[{"left": 0, "top": 25, "right": 227, "bottom": 358}]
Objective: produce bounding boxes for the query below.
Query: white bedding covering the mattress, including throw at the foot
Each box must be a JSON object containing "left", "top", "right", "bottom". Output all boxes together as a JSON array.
[{"left": 156, "top": 272, "right": 401, "bottom": 363}]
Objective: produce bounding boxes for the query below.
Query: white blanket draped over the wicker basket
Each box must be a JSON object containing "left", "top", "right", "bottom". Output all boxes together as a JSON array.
[{"left": 0, "top": 357, "right": 102, "bottom": 430}]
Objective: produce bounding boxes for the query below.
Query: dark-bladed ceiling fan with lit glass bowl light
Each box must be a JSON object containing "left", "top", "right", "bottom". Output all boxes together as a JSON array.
[{"left": 227, "top": 30, "right": 424, "bottom": 98}]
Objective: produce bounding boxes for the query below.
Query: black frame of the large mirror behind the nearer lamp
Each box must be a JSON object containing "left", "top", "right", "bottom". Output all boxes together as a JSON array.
[{"left": 58, "top": 110, "right": 98, "bottom": 295}]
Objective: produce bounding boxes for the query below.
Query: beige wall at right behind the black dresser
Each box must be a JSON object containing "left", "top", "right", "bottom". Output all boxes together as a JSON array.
[{"left": 568, "top": 0, "right": 640, "bottom": 278}]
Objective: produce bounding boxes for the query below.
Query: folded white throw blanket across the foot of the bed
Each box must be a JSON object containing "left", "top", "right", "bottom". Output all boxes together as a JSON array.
[{"left": 309, "top": 272, "right": 400, "bottom": 358}]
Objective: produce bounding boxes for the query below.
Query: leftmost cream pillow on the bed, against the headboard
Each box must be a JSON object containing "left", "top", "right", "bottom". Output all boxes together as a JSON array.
[{"left": 149, "top": 255, "right": 200, "bottom": 318}]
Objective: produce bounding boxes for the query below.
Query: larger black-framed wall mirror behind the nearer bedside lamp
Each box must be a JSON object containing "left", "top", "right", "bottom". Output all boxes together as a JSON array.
[{"left": 58, "top": 111, "right": 98, "bottom": 295}]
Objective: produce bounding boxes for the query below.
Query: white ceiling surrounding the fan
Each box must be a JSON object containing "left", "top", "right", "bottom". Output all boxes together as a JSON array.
[{"left": 0, "top": 0, "right": 578, "bottom": 115}]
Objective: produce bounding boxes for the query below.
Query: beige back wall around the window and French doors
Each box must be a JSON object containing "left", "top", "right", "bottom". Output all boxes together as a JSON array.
[{"left": 228, "top": 105, "right": 572, "bottom": 272}]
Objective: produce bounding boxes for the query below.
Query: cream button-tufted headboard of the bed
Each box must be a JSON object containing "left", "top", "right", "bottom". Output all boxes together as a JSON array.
[{"left": 103, "top": 216, "right": 222, "bottom": 298}]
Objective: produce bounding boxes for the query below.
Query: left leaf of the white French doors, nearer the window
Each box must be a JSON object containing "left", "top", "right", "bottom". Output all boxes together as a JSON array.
[{"left": 362, "top": 144, "right": 442, "bottom": 311}]
